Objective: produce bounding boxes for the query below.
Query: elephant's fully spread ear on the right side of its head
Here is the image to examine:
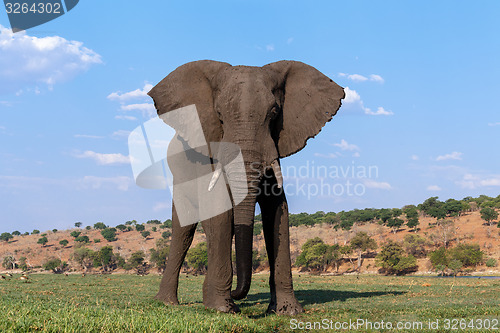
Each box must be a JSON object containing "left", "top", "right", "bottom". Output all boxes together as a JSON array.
[{"left": 263, "top": 61, "right": 345, "bottom": 157}]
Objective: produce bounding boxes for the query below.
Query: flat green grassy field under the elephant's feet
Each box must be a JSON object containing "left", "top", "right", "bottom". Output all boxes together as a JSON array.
[{"left": 0, "top": 274, "right": 500, "bottom": 332}]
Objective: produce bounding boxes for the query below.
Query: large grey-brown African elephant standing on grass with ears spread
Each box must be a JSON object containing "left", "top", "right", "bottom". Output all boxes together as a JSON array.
[{"left": 148, "top": 60, "right": 345, "bottom": 315}]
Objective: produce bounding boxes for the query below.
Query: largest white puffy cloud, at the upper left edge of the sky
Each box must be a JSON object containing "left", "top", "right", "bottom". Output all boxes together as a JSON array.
[{"left": 0, "top": 25, "right": 102, "bottom": 93}]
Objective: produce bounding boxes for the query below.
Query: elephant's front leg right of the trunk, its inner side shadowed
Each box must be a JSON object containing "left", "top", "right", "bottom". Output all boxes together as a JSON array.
[{"left": 259, "top": 193, "right": 304, "bottom": 316}]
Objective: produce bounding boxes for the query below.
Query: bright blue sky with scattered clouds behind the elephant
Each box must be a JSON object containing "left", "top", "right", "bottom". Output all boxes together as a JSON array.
[{"left": 0, "top": 0, "right": 500, "bottom": 231}]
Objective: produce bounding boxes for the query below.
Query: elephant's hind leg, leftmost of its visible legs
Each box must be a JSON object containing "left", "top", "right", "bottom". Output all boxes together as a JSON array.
[{"left": 155, "top": 207, "right": 196, "bottom": 305}]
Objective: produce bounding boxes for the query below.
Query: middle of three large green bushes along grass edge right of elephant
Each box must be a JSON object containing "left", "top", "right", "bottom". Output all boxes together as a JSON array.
[{"left": 375, "top": 241, "right": 418, "bottom": 275}]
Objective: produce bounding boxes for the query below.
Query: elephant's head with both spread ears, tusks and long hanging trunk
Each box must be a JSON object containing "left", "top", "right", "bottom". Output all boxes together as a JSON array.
[{"left": 149, "top": 60, "right": 345, "bottom": 299}]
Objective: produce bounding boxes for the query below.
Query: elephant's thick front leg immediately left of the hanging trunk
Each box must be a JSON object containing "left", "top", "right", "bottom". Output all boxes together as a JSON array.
[{"left": 202, "top": 211, "right": 240, "bottom": 313}]
